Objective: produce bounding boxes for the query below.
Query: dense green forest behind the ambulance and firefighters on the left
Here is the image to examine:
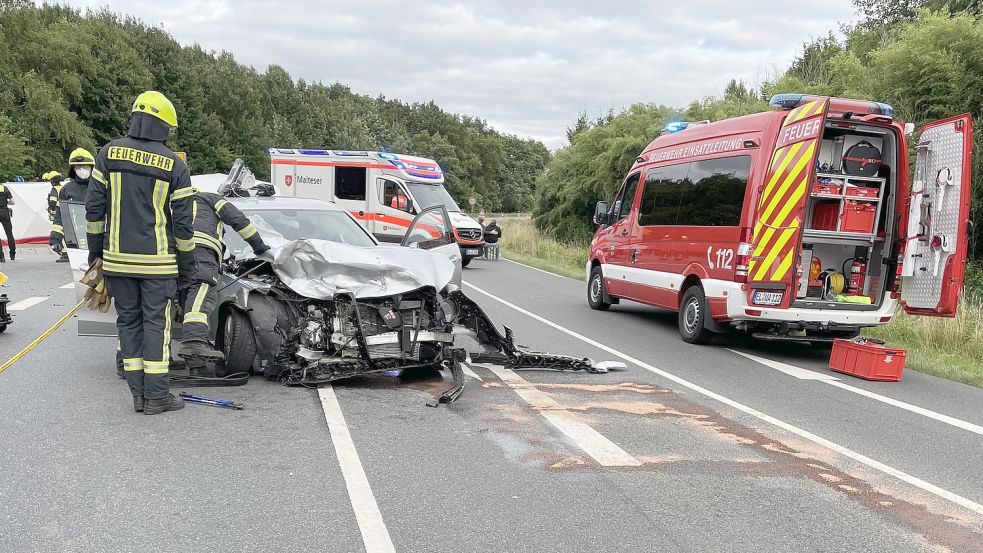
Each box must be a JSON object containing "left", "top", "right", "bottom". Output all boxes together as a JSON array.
[{"left": 0, "top": 0, "right": 550, "bottom": 211}]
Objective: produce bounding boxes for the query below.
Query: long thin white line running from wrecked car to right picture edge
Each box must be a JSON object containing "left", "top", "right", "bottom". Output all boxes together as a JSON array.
[{"left": 464, "top": 282, "right": 983, "bottom": 515}]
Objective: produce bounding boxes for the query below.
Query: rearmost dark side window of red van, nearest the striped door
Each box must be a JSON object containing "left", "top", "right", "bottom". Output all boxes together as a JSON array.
[{"left": 677, "top": 156, "right": 751, "bottom": 227}]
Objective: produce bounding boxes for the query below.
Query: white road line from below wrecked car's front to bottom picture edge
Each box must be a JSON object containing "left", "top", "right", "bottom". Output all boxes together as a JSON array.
[{"left": 317, "top": 385, "right": 396, "bottom": 553}]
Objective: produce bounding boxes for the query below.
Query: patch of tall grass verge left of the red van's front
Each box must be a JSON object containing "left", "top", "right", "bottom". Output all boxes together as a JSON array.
[{"left": 499, "top": 219, "right": 590, "bottom": 280}]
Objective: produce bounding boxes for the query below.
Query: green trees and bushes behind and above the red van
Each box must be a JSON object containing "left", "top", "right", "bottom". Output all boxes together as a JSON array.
[{"left": 534, "top": 0, "right": 983, "bottom": 259}]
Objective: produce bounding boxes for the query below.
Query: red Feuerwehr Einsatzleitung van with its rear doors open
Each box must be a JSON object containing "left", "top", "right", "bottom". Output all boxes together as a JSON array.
[{"left": 587, "top": 94, "right": 973, "bottom": 343}]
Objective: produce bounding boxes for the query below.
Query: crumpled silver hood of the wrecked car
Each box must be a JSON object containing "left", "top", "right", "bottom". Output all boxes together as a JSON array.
[{"left": 273, "top": 236, "right": 454, "bottom": 300}]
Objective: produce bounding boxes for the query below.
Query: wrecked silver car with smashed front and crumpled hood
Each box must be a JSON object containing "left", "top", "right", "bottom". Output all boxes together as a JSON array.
[{"left": 62, "top": 166, "right": 612, "bottom": 403}]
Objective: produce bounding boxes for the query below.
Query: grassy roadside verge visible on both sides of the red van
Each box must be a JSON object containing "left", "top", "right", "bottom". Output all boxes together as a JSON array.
[{"left": 499, "top": 219, "right": 983, "bottom": 388}]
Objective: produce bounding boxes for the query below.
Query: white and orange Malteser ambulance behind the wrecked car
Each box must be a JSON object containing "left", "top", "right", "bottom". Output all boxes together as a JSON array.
[{"left": 270, "top": 148, "right": 485, "bottom": 267}]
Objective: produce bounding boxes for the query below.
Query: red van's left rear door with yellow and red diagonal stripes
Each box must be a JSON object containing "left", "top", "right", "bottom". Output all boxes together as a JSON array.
[{"left": 748, "top": 97, "right": 829, "bottom": 308}]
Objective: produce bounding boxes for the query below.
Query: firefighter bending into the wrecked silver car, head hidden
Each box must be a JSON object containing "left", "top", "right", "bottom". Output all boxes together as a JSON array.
[{"left": 178, "top": 191, "right": 270, "bottom": 361}]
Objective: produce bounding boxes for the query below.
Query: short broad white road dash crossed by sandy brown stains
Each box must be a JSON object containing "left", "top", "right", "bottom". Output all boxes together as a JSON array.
[{"left": 482, "top": 365, "right": 642, "bottom": 467}]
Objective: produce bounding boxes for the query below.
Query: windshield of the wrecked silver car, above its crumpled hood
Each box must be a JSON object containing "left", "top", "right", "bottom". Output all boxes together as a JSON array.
[{"left": 225, "top": 209, "right": 375, "bottom": 257}]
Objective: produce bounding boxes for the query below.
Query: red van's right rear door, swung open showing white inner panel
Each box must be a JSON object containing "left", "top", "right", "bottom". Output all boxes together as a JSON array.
[{"left": 901, "top": 113, "right": 973, "bottom": 317}]
